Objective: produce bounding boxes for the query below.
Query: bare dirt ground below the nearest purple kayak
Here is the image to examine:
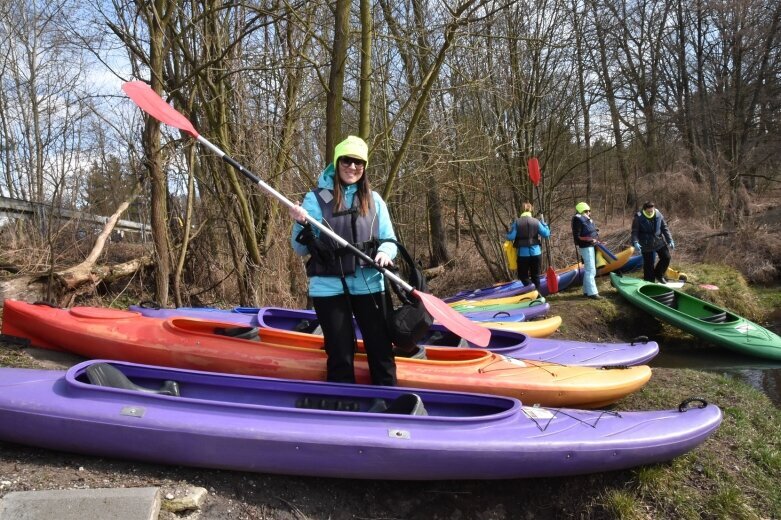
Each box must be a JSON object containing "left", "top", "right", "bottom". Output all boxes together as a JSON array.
[{"left": 0, "top": 426, "right": 628, "bottom": 520}]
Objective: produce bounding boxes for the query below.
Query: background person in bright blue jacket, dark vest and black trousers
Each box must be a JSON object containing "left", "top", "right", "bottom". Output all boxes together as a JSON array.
[{"left": 507, "top": 202, "right": 550, "bottom": 291}]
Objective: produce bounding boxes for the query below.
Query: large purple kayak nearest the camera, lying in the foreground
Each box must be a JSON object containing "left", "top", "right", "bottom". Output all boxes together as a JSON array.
[{"left": 0, "top": 360, "right": 722, "bottom": 480}]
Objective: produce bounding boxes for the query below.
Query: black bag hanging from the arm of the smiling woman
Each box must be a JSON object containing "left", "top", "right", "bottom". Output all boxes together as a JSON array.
[{"left": 380, "top": 240, "right": 434, "bottom": 357}]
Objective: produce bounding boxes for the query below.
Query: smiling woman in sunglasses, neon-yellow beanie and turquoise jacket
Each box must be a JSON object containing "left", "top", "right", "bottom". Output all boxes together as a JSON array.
[{"left": 290, "top": 135, "right": 397, "bottom": 386}]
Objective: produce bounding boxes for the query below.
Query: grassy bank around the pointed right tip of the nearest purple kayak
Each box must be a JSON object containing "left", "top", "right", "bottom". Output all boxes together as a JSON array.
[{"left": 601, "top": 369, "right": 781, "bottom": 519}]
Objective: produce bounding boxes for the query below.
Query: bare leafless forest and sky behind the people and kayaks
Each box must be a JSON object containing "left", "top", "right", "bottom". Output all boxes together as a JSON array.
[{"left": 0, "top": 0, "right": 781, "bottom": 306}]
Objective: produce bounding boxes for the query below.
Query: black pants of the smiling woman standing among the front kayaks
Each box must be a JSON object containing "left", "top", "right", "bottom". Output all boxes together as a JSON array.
[{"left": 312, "top": 293, "right": 396, "bottom": 386}]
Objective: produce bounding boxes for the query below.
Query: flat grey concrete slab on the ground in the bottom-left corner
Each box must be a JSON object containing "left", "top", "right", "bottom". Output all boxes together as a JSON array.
[{"left": 0, "top": 487, "right": 161, "bottom": 520}]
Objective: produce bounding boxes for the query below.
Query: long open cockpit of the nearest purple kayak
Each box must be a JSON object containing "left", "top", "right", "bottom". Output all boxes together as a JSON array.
[{"left": 66, "top": 360, "right": 521, "bottom": 421}]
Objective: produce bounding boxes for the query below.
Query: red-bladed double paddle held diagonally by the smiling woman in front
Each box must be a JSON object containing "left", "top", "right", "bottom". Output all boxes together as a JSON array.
[{"left": 122, "top": 81, "right": 491, "bottom": 347}]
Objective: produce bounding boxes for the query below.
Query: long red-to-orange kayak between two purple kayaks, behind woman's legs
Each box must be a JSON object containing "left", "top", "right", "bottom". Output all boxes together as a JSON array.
[{"left": 2, "top": 300, "right": 651, "bottom": 408}]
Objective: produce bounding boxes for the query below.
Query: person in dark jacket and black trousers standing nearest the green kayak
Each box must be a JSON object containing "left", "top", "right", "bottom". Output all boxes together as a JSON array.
[{"left": 632, "top": 201, "right": 675, "bottom": 283}]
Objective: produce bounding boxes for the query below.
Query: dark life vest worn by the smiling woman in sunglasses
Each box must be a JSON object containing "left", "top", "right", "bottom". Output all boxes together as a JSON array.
[{"left": 306, "top": 188, "right": 380, "bottom": 276}]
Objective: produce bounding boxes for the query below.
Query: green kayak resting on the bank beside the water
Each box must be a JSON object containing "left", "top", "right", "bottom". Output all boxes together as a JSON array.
[{"left": 610, "top": 273, "right": 781, "bottom": 359}]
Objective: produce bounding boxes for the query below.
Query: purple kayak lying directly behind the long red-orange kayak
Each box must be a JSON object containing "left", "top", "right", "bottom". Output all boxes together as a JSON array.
[{"left": 130, "top": 305, "right": 659, "bottom": 367}]
